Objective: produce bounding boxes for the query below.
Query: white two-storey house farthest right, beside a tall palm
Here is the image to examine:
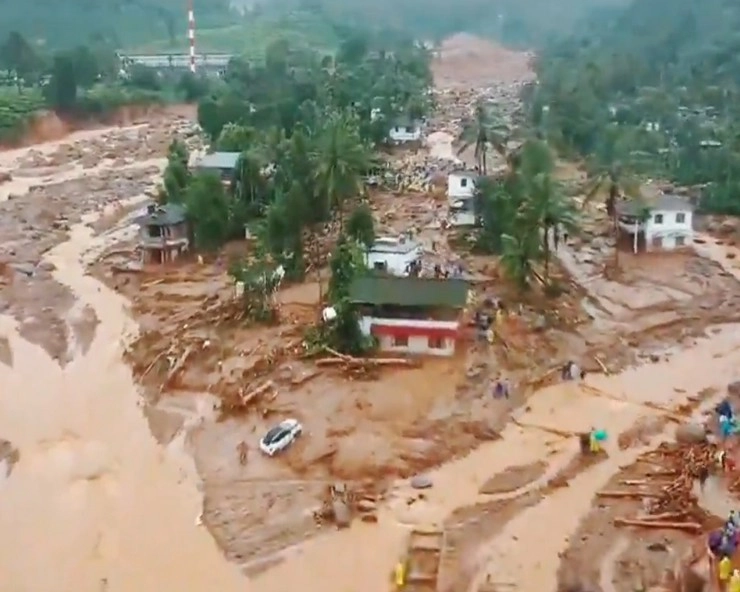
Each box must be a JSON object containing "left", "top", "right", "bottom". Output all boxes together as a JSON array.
[{"left": 617, "top": 195, "right": 694, "bottom": 253}]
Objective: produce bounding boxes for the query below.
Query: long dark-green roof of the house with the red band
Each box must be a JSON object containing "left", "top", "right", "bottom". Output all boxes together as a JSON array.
[{"left": 349, "top": 276, "right": 469, "bottom": 308}]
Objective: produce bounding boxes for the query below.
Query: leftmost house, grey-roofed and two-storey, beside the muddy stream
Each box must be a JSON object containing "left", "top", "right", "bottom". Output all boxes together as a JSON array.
[{"left": 136, "top": 204, "right": 190, "bottom": 265}]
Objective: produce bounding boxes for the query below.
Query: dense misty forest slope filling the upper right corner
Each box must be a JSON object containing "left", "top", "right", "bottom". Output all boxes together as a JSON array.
[{"left": 530, "top": 0, "right": 740, "bottom": 214}]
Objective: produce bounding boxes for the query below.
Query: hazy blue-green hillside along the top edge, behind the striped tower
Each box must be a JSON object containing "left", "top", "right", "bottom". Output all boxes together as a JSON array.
[{"left": 0, "top": 0, "right": 628, "bottom": 53}]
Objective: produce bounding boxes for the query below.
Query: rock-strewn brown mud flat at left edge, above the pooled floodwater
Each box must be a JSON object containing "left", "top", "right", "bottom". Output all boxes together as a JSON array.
[{"left": 0, "top": 111, "right": 199, "bottom": 364}]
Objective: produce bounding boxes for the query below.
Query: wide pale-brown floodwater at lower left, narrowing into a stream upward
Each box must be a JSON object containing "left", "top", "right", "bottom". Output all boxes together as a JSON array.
[{"left": 0, "top": 217, "right": 244, "bottom": 592}]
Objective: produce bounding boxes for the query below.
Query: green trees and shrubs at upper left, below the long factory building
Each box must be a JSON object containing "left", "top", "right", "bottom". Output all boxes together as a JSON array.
[{"left": 0, "top": 32, "right": 207, "bottom": 142}]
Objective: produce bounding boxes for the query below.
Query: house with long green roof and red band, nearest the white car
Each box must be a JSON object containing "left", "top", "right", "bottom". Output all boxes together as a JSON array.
[{"left": 350, "top": 276, "right": 469, "bottom": 356}]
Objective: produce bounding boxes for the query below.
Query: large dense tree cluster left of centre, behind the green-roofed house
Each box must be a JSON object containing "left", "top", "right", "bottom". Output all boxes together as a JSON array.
[{"left": 161, "top": 28, "right": 431, "bottom": 351}]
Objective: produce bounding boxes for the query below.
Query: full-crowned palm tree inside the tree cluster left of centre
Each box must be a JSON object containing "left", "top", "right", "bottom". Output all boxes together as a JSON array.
[{"left": 313, "top": 113, "right": 372, "bottom": 228}]
